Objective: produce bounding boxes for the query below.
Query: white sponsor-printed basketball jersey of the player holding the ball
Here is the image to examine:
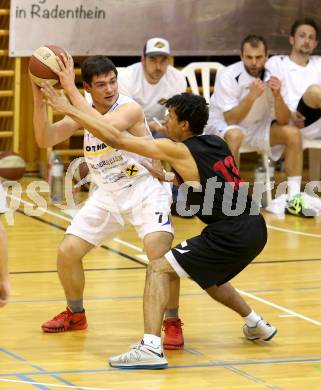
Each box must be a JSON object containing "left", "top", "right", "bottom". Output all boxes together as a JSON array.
[{"left": 84, "top": 95, "right": 152, "bottom": 191}]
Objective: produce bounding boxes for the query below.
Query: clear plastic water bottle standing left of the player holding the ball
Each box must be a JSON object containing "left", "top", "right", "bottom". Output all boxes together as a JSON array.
[{"left": 49, "top": 151, "right": 64, "bottom": 203}]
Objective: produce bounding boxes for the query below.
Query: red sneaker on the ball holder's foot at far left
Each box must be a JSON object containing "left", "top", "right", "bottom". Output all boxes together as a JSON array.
[{"left": 41, "top": 307, "right": 88, "bottom": 333}]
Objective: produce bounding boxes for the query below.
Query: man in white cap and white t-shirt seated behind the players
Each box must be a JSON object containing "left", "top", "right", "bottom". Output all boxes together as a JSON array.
[{"left": 118, "top": 37, "right": 187, "bottom": 137}]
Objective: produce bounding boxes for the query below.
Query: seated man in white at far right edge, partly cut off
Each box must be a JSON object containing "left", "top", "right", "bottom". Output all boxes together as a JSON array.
[{"left": 266, "top": 18, "right": 321, "bottom": 193}]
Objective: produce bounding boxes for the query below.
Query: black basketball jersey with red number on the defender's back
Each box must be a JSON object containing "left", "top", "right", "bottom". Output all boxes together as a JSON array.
[{"left": 178, "top": 135, "right": 258, "bottom": 224}]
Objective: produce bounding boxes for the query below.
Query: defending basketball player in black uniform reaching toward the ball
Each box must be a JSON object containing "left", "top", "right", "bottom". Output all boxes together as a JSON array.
[{"left": 43, "top": 85, "right": 277, "bottom": 369}]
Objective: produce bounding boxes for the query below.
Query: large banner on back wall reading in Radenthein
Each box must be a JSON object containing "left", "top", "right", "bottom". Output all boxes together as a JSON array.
[{"left": 9, "top": 0, "right": 321, "bottom": 56}]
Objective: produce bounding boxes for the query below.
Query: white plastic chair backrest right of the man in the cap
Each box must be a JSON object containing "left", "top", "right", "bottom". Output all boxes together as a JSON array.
[{"left": 181, "top": 62, "right": 225, "bottom": 103}]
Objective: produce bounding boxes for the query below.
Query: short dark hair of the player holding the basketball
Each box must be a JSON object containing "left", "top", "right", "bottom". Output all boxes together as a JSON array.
[{"left": 81, "top": 55, "right": 118, "bottom": 84}]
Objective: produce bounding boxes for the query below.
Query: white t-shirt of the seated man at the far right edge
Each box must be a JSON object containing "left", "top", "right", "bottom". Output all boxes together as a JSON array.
[{"left": 265, "top": 56, "right": 321, "bottom": 111}]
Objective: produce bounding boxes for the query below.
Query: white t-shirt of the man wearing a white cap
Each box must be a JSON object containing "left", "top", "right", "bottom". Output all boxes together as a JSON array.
[{"left": 118, "top": 62, "right": 187, "bottom": 121}]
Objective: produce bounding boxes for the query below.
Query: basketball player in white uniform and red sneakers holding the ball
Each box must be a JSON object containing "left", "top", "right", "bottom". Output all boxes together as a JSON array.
[{"left": 32, "top": 55, "right": 183, "bottom": 349}]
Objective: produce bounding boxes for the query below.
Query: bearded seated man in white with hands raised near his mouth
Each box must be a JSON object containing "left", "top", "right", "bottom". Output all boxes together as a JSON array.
[{"left": 205, "top": 35, "right": 315, "bottom": 216}]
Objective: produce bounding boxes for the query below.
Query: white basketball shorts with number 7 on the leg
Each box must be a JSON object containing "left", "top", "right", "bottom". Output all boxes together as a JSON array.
[{"left": 66, "top": 176, "right": 174, "bottom": 246}]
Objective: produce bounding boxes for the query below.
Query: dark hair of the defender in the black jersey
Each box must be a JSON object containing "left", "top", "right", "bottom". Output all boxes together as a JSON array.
[{"left": 166, "top": 92, "right": 208, "bottom": 135}]
